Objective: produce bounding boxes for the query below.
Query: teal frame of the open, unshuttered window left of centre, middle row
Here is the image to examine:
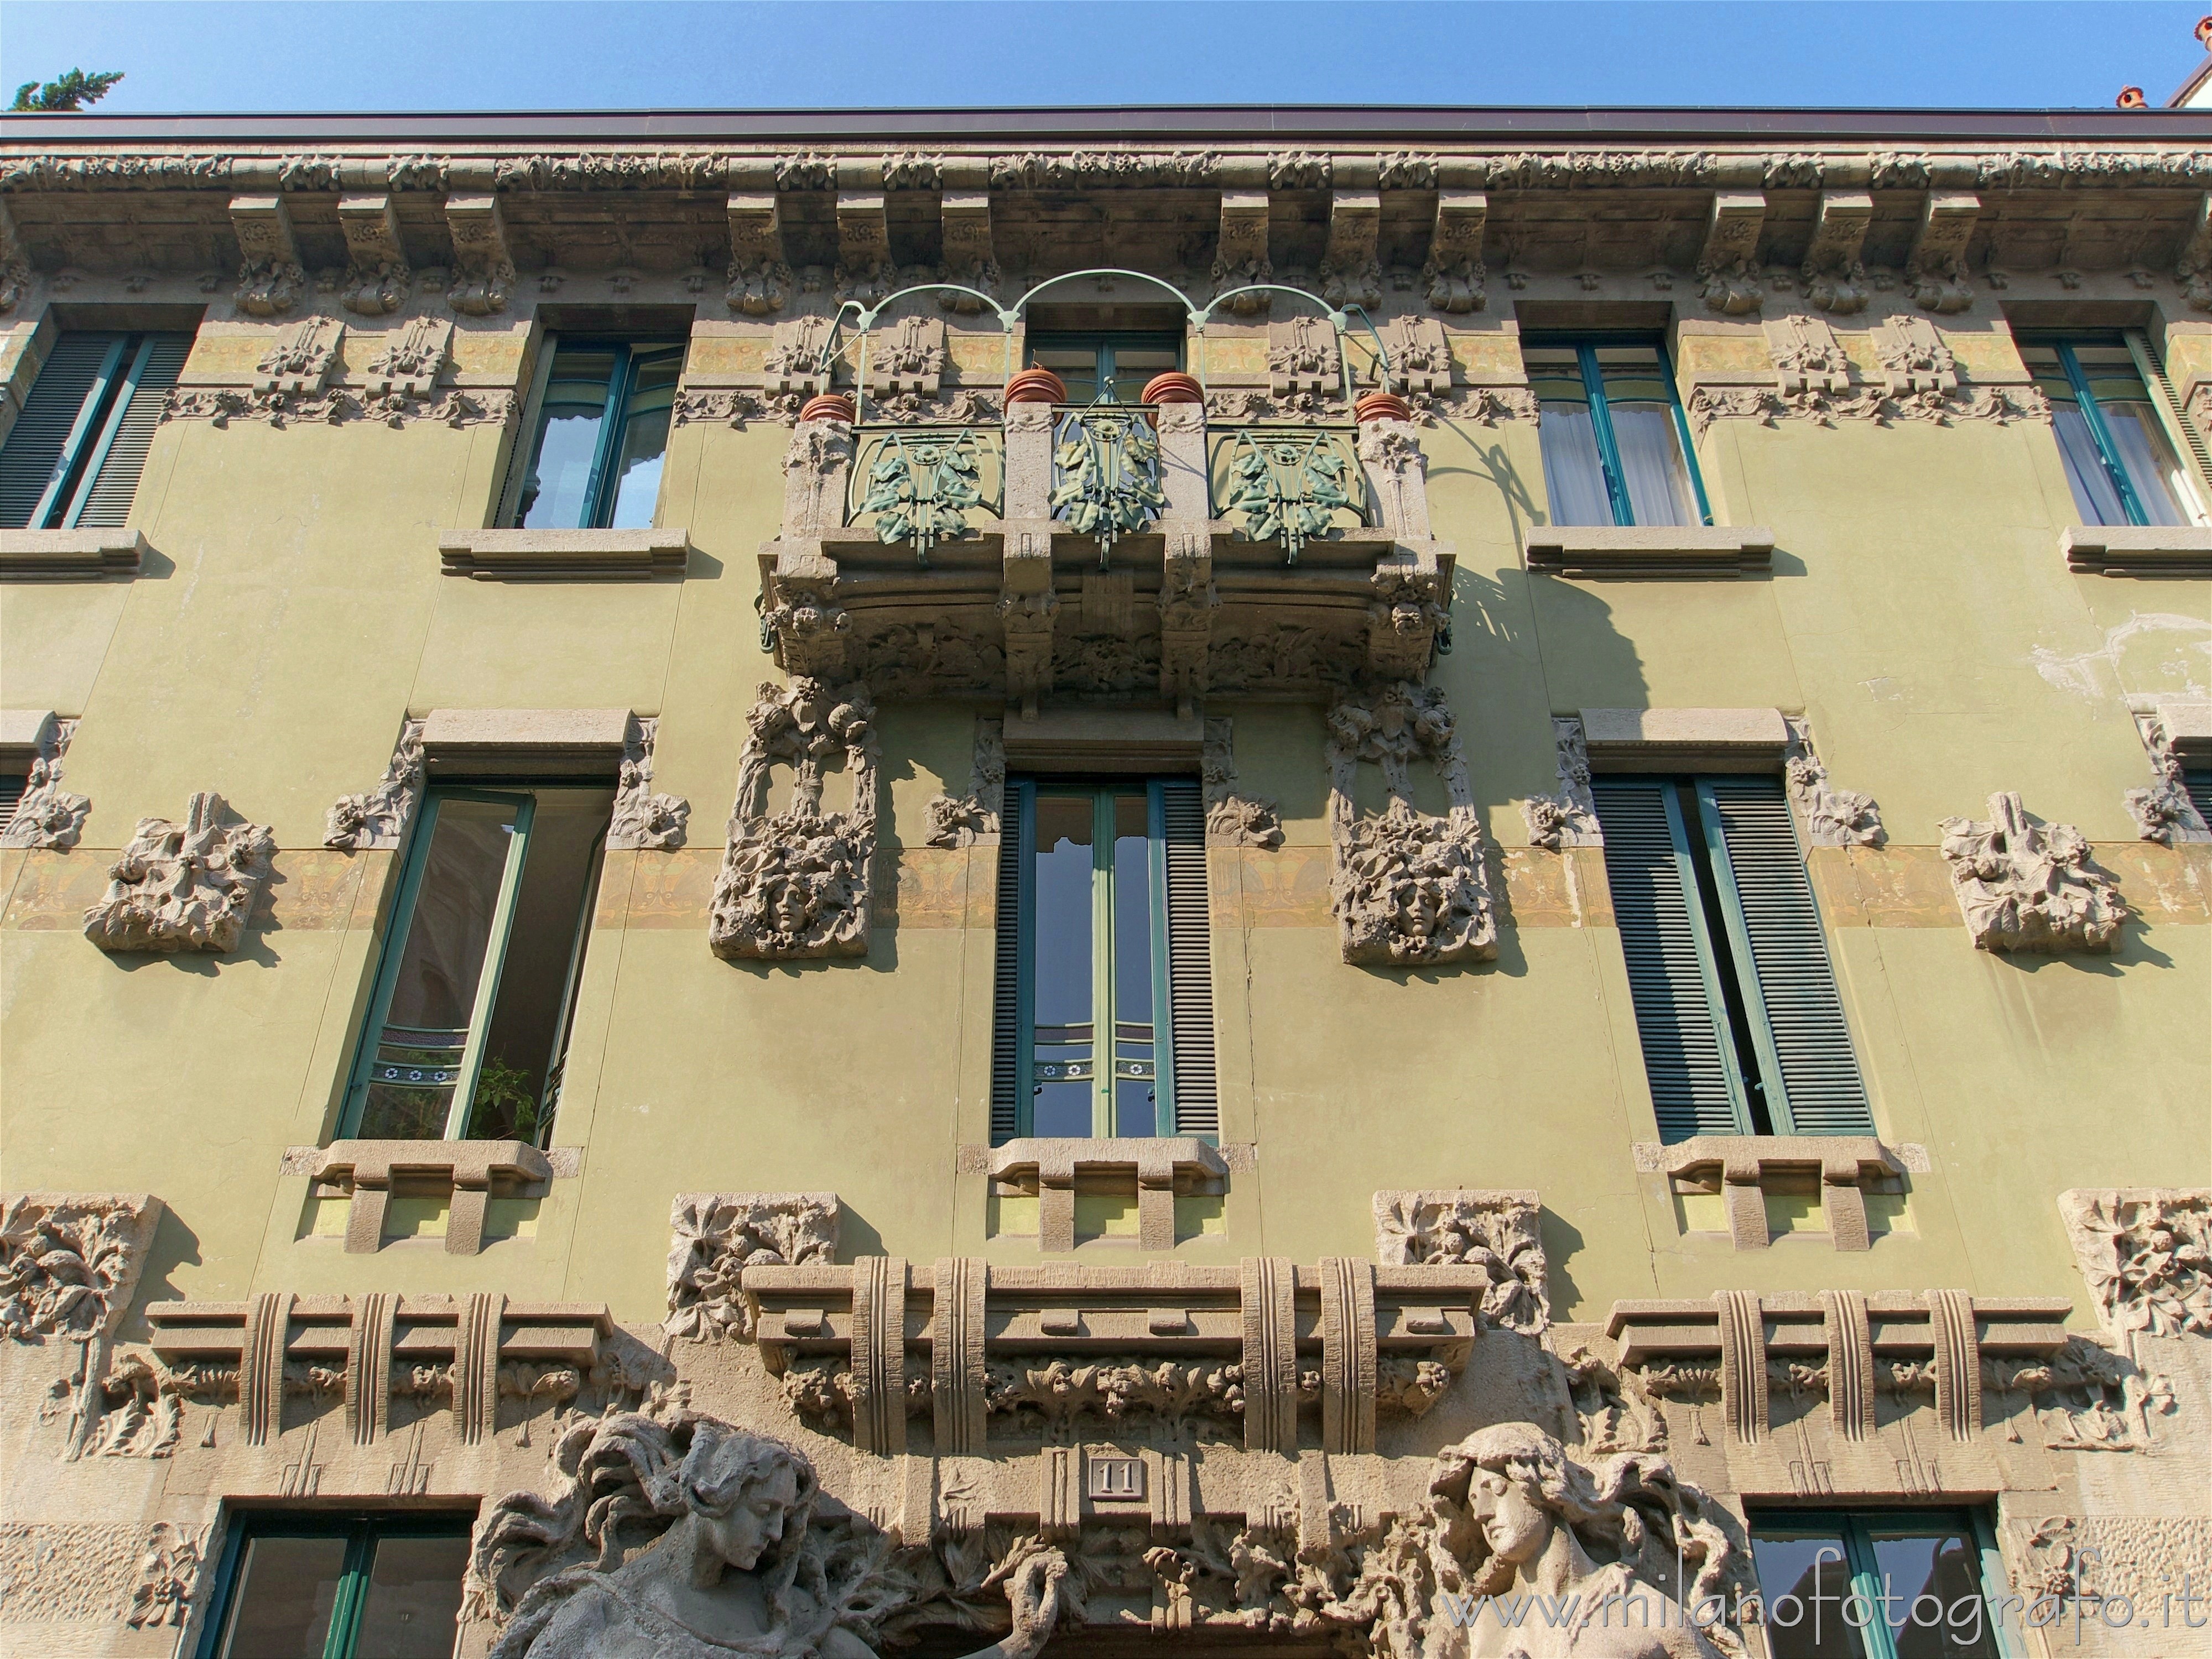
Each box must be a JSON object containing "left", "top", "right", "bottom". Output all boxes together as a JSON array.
[{"left": 339, "top": 781, "right": 604, "bottom": 1144}]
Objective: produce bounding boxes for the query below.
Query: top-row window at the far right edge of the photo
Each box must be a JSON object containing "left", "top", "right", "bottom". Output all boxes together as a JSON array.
[{"left": 2020, "top": 334, "right": 2205, "bottom": 524}]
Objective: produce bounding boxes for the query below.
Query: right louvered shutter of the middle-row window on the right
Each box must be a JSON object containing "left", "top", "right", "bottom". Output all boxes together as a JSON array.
[{"left": 1696, "top": 776, "right": 1873, "bottom": 1135}]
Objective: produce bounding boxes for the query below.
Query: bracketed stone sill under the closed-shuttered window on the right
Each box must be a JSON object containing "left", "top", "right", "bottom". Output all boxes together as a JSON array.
[{"left": 1635, "top": 1135, "right": 1929, "bottom": 1250}]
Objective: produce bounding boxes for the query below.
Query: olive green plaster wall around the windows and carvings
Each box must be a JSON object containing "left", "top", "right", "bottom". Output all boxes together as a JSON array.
[{"left": 0, "top": 323, "right": 2212, "bottom": 1354}]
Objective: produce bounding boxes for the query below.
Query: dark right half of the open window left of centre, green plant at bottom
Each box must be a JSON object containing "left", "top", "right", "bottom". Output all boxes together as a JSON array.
[{"left": 462, "top": 790, "right": 615, "bottom": 1144}]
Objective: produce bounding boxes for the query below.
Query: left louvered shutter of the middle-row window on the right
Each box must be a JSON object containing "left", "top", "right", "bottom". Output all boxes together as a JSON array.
[{"left": 1590, "top": 779, "right": 1750, "bottom": 1141}]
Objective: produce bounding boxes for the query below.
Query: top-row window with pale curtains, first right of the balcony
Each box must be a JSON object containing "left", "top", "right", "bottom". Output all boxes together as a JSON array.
[{"left": 1522, "top": 334, "right": 1712, "bottom": 524}]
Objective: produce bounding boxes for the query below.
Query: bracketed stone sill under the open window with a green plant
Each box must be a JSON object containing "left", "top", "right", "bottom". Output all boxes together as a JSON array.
[{"left": 283, "top": 1141, "right": 582, "bottom": 1256}]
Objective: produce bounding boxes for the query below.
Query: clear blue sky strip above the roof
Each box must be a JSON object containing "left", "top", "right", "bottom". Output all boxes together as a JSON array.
[{"left": 0, "top": 0, "right": 2205, "bottom": 111}]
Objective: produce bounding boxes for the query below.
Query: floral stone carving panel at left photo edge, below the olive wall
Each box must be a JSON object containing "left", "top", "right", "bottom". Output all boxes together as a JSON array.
[{"left": 0, "top": 1192, "right": 162, "bottom": 1340}]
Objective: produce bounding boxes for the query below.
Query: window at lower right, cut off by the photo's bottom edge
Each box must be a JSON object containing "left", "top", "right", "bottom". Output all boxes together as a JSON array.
[{"left": 1752, "top": 1509, "right": 2011, "bottom": 1659}]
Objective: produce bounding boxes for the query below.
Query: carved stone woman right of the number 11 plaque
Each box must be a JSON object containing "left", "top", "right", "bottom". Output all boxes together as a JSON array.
[{"left": 1429, "top": 1422, "right": 1743, "bottom": 1659}]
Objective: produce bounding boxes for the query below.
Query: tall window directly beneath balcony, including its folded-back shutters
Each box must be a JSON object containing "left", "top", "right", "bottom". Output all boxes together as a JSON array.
[{"left": 991, "top": 779, "right": 1221, "bottom": 1141}]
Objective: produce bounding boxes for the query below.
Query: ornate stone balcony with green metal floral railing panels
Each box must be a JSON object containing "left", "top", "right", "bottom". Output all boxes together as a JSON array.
[{"left": 761, "top": 369, "right": 1453, "bottom": 710}]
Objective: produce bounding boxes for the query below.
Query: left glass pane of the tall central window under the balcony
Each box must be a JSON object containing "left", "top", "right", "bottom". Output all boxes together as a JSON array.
[{"left": 1031, "top": 794, "right": 1093, "bottom": 1135}]
